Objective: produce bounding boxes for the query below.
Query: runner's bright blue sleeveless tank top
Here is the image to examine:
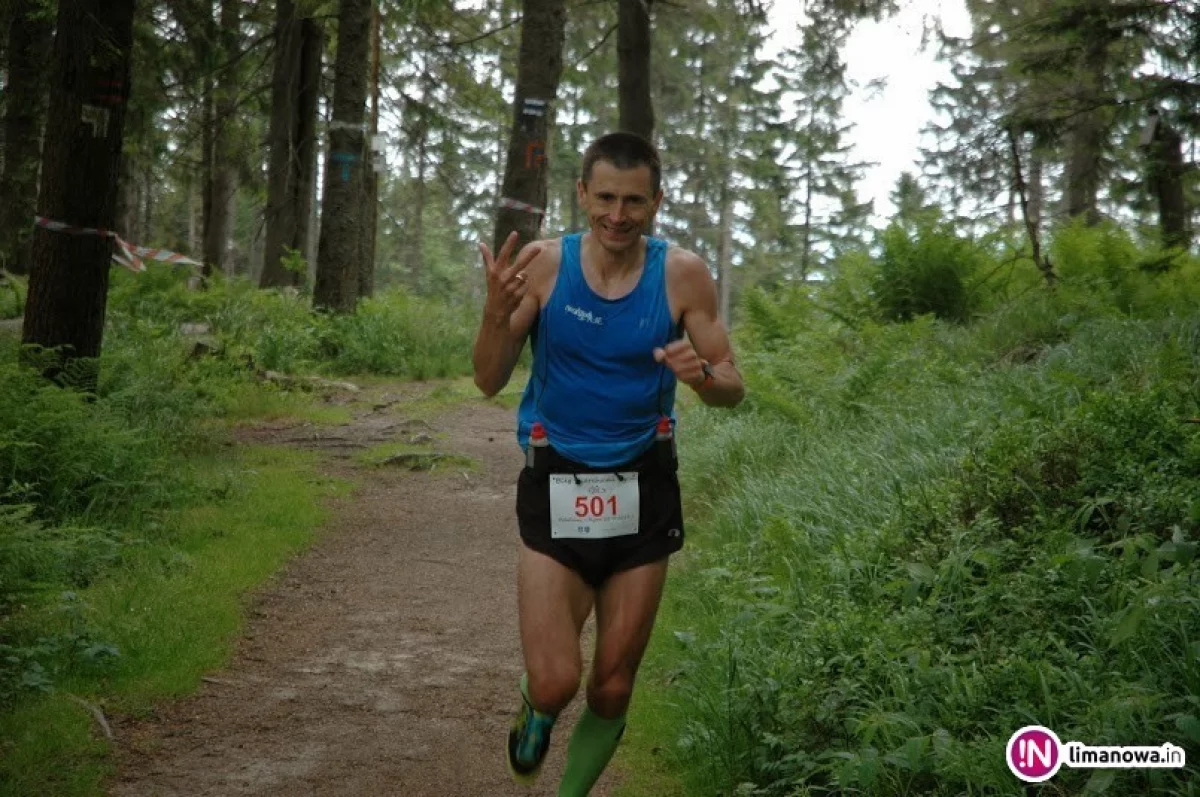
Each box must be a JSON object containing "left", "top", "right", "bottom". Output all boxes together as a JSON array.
[{"left": 517, "top": 234, "right": 678, "bottom": 468}]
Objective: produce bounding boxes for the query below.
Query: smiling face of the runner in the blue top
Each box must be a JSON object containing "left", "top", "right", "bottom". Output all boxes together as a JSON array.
[{"left": 576, "top": 161, "right": 662, "bottom": 252}]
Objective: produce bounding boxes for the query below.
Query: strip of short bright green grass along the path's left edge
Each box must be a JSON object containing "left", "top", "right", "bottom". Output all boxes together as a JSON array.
[{"left": 0, "top": 448, "right": 346, "bottom": 796}]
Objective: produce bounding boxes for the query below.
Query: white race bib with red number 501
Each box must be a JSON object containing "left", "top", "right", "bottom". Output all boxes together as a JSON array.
[{"left": 550, "top": 472, "right": 641, "bottom": 540}]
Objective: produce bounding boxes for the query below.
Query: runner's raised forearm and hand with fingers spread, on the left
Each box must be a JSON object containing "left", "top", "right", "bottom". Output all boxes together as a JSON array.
[{"left": 473, "top": 233, "right": 544, "bottom": 397}]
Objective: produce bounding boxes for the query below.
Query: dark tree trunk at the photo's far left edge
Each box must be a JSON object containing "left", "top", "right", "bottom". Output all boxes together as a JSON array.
[{"left": 0, "top": 0, "right": 54, "bottom": 274}]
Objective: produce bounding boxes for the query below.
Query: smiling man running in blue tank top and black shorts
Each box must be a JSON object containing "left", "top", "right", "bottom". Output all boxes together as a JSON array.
[{"left": 474, "top": 133, "right": 744, "bottom": 797}]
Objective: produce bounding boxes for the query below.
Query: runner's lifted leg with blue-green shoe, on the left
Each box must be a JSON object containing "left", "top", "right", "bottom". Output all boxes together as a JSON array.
[{"left": 508, "top": 546, "right": 593, "bottom": 783}]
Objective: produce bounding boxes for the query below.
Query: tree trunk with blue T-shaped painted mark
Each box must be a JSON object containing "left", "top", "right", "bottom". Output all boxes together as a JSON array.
[{"left": 312, "top": 0, "right": 371, "bottom": 313}]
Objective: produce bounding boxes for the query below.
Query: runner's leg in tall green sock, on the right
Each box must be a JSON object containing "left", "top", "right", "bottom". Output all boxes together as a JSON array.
[{"left": 558, "top": 558, "right": 667, "bottom": 797}]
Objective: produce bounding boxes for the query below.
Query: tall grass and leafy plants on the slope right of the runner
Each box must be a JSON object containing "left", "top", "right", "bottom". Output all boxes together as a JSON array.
[{"left": 647, "top": 230, "right": 1200, "bottom": 797}]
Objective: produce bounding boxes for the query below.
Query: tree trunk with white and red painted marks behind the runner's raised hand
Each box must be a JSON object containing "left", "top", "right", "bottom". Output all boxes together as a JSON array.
[{"left": 493, "top": 0, "right": 566, "bottom": 251}]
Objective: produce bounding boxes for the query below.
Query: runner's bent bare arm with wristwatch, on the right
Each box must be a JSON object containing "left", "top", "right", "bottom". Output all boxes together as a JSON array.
[{"left": 654, "top": 250, "right": 745, "bottom": 407}]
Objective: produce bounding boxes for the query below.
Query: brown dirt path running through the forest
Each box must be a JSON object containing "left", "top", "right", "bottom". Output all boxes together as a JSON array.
[{"left": 109, "top": 386, "right": 611, "bottom": 797}]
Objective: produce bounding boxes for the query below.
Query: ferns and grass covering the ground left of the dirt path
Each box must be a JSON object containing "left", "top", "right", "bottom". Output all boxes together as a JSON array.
[{"left": 0, "top": 307, "right": 349, "bottom": 795}]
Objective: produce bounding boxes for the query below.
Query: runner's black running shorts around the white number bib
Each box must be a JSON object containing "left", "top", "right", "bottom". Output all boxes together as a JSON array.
[{"left": 517, "top": 448, "right": 683, "bottom": 589}]
